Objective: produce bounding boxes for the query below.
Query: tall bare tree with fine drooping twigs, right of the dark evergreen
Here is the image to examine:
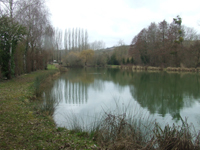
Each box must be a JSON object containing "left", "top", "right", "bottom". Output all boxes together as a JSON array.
[{"left": 17, "top": 0, "right": 50, "bottom": 72}]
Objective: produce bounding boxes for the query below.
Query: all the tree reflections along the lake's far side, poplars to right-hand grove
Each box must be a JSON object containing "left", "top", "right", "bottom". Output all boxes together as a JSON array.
[{"left": 44, "top": 68, "right": 200, "bottom": 120}]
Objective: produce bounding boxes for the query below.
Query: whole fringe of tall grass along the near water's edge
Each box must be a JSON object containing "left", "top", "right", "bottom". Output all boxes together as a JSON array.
[{"left": 63, "top": 102, "right": 200, "bottom": 150}]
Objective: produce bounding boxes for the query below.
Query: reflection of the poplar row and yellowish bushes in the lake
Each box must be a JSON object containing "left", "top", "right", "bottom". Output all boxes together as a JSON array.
[{"left": 47, "top": 68, "right": 104, "bottom": 104}]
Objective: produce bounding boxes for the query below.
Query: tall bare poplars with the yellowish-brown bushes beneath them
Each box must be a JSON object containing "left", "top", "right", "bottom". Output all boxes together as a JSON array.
[{"left": 52, "top": 28, "right": 105, "bottom": 63}]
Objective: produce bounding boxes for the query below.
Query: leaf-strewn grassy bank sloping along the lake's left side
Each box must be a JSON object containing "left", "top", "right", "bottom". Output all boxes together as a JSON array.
[{"left": 0, "top": 66, "right": 96, "bottom": 150}]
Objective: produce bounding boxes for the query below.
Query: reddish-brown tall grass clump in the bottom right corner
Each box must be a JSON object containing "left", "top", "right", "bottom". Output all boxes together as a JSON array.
[{"left": 153, "top": 119, "right": 200, "bottom": 150}]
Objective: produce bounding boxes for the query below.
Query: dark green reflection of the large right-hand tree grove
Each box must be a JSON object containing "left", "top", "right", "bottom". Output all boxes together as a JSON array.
[{"left": 130, "top": 72, "right": 200, "bottom": 120}]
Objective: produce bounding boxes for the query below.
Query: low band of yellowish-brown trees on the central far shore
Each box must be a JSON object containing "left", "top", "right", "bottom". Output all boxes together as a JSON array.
[{"left": 62, "top": 41, "right": 131, "bottom": 67}]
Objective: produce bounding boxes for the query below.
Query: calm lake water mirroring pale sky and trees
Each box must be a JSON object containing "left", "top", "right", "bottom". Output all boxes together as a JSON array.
[{"left": 44, "top": 68, "right": 200, "bottom": 130}]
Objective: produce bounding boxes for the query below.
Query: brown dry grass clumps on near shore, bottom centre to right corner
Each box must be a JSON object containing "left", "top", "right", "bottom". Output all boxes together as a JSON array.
[{"left": 93, "top": 113, "right": 200, "bottom": 150}]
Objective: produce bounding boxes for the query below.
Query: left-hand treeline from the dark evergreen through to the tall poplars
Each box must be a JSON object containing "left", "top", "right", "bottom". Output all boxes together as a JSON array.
[{"left": 0, "top": 0, "right": 108, "bottom": 79}]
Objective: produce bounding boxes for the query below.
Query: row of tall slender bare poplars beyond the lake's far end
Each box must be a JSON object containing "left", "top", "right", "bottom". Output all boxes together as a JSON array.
[{"left": 53, "top": 28, "right": 90, "bottom": 63}]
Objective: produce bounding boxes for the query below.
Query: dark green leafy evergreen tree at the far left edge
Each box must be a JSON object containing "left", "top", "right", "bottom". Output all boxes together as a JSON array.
[{"left": 0, "top": 16, "right": 25, "bottom": 79}]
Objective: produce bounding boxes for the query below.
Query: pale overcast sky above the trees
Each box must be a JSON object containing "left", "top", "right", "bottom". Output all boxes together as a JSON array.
[{"left": 47, "top": 0, "right": 200, "bottom": 47}]
